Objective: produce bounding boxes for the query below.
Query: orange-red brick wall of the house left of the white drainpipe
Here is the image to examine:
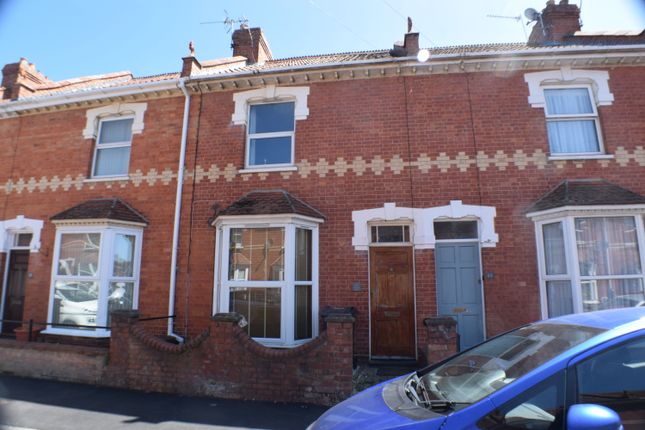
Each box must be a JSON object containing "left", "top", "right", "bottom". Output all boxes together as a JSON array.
[{"left": 0, "top": 97, "right": 184, "bottom": 332}]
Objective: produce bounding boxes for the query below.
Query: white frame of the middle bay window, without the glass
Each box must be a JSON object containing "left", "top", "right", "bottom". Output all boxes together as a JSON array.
[{"left": 213, "top": 215, "right": 322, "bottom": 348}]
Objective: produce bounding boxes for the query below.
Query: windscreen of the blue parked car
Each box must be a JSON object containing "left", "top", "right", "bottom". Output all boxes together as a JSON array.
[{"left": 423, "top": 323, "right": 605, "bottom": 403}]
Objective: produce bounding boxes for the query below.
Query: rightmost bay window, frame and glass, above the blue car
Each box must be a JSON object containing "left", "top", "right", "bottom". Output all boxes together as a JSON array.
[{"left": 536, "top": 212, "right": 645, "bottom": 317}]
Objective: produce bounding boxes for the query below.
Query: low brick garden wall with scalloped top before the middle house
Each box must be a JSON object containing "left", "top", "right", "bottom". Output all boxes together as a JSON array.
[{"left": 104, "top": 312, "right": 354, "bottom": 405}]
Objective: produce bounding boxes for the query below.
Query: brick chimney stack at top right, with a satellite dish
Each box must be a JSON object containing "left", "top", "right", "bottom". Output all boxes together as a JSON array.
[{"left": 528, "top": 0, "right": 580, "bottom": 45}]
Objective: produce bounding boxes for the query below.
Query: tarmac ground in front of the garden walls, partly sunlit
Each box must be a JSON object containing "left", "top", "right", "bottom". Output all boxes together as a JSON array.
[{"left": 0, "top": 374, "right": 327, "bottom": 430}]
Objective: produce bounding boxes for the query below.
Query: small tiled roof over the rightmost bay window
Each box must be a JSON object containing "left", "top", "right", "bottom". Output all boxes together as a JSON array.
[{"left": 527, "top": 179, "right": 645, "bottom": 213}]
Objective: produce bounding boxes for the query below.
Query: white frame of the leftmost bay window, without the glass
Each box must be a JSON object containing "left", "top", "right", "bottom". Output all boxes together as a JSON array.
[{"left": 43, "top": 224, "right": 143, "bottom": 337}]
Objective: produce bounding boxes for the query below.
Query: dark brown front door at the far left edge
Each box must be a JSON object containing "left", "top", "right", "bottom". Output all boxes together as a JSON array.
[{"left": 2, "top": 250, "right": 29, "bottom": 334}]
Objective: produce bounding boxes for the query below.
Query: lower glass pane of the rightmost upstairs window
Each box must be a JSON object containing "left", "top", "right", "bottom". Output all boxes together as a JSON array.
[{"left": 546, "top": 119, "right": 600, "bottom": 154}]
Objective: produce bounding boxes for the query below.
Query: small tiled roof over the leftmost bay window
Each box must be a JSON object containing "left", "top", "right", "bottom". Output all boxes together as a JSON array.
[{"left": 51, "top": 198, "right": 148, "bottom": 225}]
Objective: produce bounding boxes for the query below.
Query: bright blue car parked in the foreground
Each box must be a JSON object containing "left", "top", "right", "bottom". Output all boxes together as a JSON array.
[{"left": 309, "top": 307, "right": 645, "bottom": 430}]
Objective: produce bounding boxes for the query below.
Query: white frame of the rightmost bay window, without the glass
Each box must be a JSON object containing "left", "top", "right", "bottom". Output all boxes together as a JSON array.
[{"left": 527, "top": 206, "right": 645, "bottom": 319}]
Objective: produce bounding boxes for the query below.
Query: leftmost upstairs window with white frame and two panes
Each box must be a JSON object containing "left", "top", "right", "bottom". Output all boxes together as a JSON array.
[{"left": 92, "top": 118, "right": 134, "bottom": 178}]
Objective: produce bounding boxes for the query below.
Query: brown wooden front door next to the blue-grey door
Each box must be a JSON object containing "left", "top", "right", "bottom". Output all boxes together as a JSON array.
[{"left": 370, "top": 246, "right": 416, "bottom": 358}]
